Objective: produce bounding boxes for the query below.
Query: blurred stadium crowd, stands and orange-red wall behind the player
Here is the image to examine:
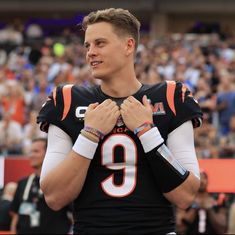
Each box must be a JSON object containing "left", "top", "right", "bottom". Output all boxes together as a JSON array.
[{"left": 0, "top": 0, "right": 235, "bottom": 234}]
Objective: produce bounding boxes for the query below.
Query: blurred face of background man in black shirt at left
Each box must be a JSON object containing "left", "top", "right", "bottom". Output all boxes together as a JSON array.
[{"left": 30, "top": 141, "right": 46, "bottom": 169}]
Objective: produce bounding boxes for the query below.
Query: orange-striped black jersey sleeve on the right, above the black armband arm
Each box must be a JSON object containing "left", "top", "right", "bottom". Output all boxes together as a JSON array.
[{"left": 166, "top": 81, "right": 203, "bottom": 131}]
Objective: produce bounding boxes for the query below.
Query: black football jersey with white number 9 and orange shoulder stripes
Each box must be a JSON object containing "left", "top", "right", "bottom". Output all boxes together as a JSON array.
[{"left": 38, "top": 81, "right": 202, "bottom": 235}]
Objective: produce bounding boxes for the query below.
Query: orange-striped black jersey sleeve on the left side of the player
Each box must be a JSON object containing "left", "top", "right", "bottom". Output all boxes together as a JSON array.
[{"left": 37, "top": 85, "right": 73, "bottom": 132}]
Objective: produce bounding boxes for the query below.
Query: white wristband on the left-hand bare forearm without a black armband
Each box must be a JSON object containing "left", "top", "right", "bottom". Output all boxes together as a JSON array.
[{"left": 73, "top": 134, "right": 98, "bottom": 159}]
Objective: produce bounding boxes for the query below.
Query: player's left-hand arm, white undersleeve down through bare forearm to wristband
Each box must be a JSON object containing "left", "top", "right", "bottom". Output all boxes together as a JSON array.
[{"left": 40, "top": 125, "right": 98, "bottom": 210}]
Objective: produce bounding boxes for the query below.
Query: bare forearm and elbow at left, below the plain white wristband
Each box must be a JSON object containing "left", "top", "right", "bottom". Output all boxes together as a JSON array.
[{"left": 41, "top": 150, "right": 91, "bottom": 210}]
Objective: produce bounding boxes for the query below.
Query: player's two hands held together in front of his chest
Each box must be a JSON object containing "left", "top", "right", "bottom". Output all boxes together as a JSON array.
[{"left": 85, "top": 95, "right": 153, "bottom": 135}]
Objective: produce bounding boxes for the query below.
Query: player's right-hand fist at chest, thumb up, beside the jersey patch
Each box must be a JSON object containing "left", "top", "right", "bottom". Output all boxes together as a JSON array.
[{"left": 121, "top": 95, "right": 153, "bottom": 131}]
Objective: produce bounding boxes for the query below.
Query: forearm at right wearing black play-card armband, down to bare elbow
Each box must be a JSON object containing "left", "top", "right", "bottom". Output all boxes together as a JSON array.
[{"left": 146, "top": 141, "right": 200, "bottom": 209}]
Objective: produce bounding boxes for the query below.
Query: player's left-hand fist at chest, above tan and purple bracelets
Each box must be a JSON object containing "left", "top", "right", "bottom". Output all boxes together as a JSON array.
[{"left": 85, "top": 99, "right": 120, "bottom": 135}]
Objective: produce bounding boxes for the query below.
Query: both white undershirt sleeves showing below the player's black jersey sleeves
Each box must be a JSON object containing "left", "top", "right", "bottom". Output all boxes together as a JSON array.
[{"left": 40, "top": 121, "right": 200, "bottom": 182}]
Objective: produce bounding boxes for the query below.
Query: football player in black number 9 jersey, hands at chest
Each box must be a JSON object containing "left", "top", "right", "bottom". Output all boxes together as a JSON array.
[{"left": 38, "top": 8, "right": 202, "bottom": 235}]
